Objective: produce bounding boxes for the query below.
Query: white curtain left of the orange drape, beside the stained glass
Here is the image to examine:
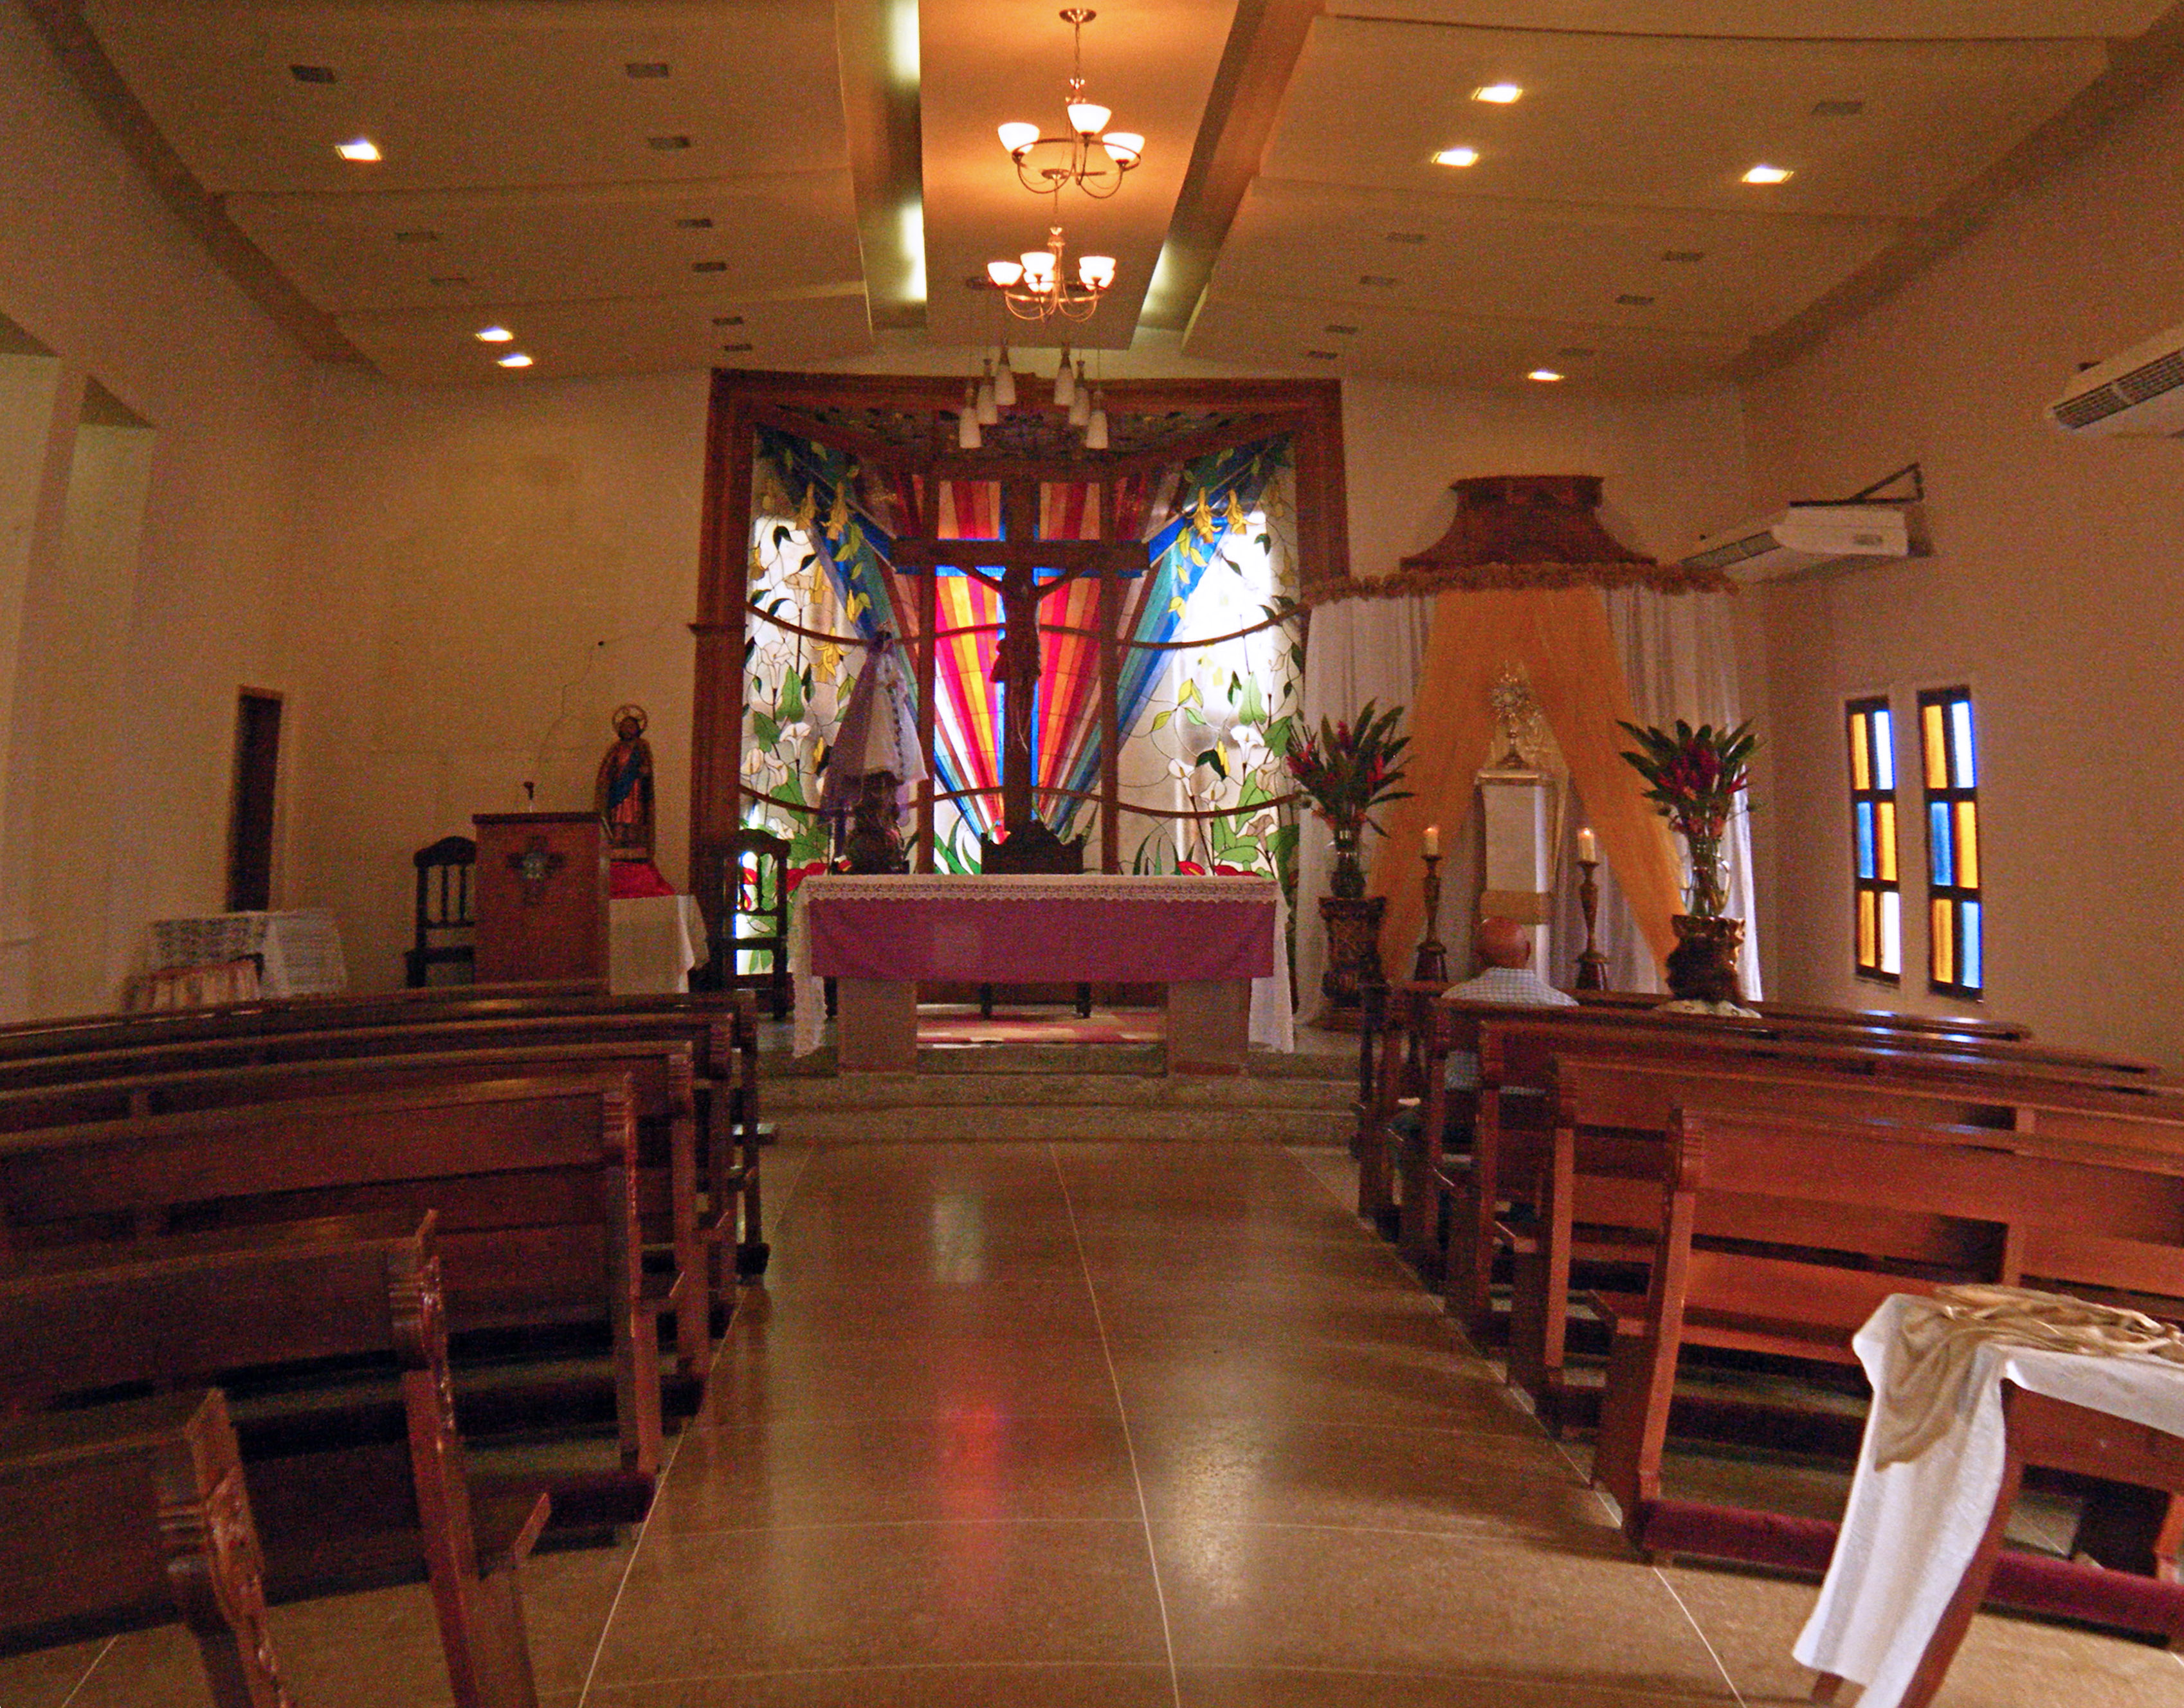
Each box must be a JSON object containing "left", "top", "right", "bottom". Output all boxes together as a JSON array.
[{"left": 1297, "top": 599, "right": 1433, "bottom": 1018}]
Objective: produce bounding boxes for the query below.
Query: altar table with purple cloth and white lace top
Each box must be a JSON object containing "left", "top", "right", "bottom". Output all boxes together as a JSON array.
[{"left": 788, "top": 874, "right": 1293, "bottom": 1073}]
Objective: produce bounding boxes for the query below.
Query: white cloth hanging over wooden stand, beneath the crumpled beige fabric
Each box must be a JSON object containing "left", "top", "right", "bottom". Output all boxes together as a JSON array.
[{"left": 1796, "top": 1293, "right": 2184, "bottom": 1708}]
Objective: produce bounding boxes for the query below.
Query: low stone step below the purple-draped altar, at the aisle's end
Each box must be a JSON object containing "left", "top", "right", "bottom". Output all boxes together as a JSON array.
[{"left": 762, "top": 1044, "right": 1356, "bottom": 1145}]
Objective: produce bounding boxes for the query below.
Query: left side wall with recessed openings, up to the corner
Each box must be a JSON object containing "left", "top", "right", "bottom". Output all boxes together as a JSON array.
[{"left": 0, "top": 5, "right": 310, "bottom": 1015}]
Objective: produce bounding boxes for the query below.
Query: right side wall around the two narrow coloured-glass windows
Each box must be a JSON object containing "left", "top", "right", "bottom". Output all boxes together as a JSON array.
[{"left": 1745, "top": 77, "right": 2184, "bottom": 1066}]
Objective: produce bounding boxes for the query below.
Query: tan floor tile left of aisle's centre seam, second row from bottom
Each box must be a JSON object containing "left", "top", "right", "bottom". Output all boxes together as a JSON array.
[{"left": 581, "top": 1522, "right": 1166, "bottom": 1684}]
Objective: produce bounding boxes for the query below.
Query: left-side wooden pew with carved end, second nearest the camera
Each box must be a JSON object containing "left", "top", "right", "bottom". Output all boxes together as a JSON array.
[{"left": 0, "top": 1214, "right": 548, "bottom": 1708}]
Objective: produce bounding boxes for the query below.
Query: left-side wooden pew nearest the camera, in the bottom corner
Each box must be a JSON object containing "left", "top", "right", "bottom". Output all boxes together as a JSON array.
[{"left": 0, "top": 1389, "right": 295, "bottom": 1708}]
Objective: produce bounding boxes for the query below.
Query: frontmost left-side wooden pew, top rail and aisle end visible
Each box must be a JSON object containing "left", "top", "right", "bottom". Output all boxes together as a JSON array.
[{"left": 0, "top": 998, "right": 767, "bottom": 1278}]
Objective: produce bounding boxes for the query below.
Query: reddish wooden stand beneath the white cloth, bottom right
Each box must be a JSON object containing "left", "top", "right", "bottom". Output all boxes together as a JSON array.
[{"left": 1813, "top": 1383, "right": 2184, "bottom": 1708}]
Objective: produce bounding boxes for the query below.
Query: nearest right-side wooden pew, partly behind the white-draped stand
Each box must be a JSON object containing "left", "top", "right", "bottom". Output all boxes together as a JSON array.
[{"left": 1594, "top": 1109, "right": 2184, "bottom": 1634}]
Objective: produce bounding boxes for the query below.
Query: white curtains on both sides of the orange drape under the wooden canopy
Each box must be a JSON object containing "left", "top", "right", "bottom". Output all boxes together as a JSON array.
[{"left": 1297, "top": 588, "right": 1763, "bottom": 1015}]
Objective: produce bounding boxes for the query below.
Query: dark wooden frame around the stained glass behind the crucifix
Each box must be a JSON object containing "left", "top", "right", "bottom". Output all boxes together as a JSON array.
[{"left": 690, "top": 369, "right": 1350, "bottom": 871}]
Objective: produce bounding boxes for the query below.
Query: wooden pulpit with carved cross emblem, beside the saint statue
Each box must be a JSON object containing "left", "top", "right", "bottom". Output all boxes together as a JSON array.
[{"left": 472, "top": 812, "right": 607, "bottom": 985}]
